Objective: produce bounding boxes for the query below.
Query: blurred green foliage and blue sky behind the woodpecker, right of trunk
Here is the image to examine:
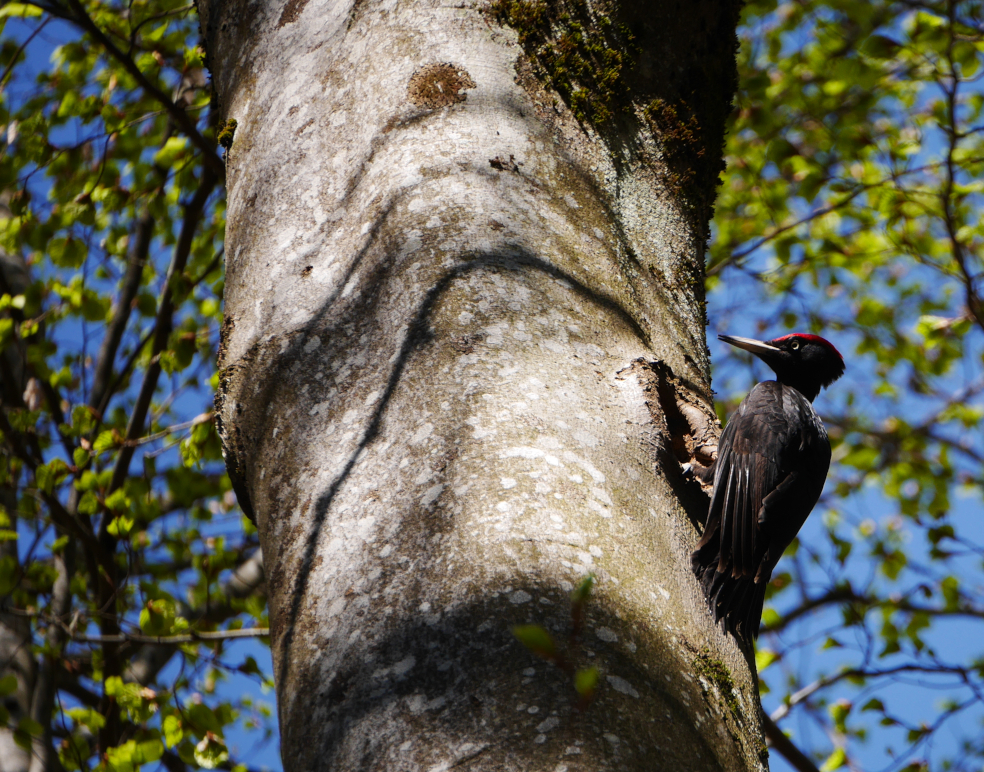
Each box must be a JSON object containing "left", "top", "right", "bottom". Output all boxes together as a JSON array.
[{"left": 707, "top": 0, "right": 984, "bottom": 770}]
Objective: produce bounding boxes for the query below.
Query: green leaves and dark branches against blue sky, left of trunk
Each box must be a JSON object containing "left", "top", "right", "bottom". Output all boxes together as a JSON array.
[{"left": 0, "top": 0, "right": 272, "bottom": 770}]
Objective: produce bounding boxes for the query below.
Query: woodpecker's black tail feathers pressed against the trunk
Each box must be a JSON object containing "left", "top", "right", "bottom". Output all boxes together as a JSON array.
[{"left": 691, "top": 550, "right": 769, "bottom": 646}]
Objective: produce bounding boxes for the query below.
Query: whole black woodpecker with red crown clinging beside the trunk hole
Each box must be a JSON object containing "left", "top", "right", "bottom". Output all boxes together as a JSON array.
[{"left": 691, "top": 333, "right": 844, "bottom": 645}]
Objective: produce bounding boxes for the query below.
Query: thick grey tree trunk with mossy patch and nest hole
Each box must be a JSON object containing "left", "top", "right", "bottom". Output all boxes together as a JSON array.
[{"left": 199, "top": 0, "right": 764, "bottom": 772}]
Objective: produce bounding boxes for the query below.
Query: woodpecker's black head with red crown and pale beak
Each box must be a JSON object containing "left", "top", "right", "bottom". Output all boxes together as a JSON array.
[{"left": 718, "top": 332, "right": 844, "bottom": 401}]
